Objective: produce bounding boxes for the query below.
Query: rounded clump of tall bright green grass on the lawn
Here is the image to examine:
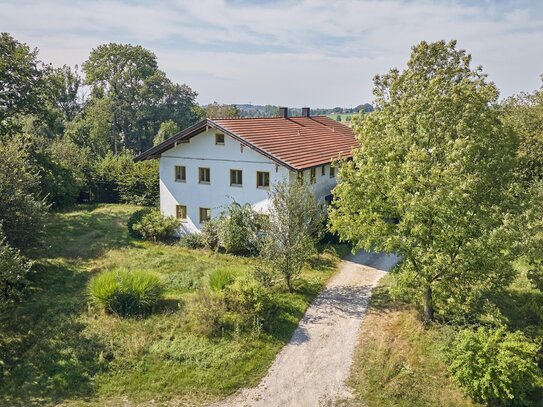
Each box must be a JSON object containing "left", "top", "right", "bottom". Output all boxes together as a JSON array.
[{"left": 88, "top": 270, "right": 164, "bottom": 316}]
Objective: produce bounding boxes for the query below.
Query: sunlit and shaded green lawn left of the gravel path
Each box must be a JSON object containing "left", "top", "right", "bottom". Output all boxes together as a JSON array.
[{"left": 0, "top": 205, "right": 344, "bottom": 405}]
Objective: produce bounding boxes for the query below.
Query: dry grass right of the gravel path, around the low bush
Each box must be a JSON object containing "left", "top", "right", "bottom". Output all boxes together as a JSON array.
[{"left": 347, "top": 265, "right": 543, "bottom": 407}]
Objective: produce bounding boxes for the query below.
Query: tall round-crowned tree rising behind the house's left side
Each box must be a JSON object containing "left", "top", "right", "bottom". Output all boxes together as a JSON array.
[{"left": 83, "top": 43, "right": 200, "bottom": 153}]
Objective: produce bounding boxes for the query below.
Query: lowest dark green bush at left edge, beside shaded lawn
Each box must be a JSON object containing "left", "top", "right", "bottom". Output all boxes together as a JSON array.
[{"left": 0, "top": 228, "right": 30, "bottom": 309}]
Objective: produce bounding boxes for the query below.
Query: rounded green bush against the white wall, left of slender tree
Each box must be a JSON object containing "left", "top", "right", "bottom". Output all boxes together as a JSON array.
[{"left": 219, "top": 202, "right": 263, "bottom": 255}]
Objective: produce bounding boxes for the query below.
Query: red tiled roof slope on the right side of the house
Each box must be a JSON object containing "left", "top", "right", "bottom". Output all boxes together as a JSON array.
[{"left": 215, "top": 116, "right": 358, "bottom": 170}]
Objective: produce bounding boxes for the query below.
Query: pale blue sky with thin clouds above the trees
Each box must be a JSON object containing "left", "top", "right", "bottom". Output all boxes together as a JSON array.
[{"left": 0, "top": 0, "right": 543, "bottom": 107}]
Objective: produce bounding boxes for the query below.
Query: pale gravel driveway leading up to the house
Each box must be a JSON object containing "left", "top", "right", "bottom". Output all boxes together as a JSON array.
[{"left": 213, "top": 252, "right": 397, "bottom": 407}]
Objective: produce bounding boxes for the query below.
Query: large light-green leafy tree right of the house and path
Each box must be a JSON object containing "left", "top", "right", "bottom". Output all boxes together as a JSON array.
[{"left": 330, "top": 41, "right": 517, "bottom": 321}]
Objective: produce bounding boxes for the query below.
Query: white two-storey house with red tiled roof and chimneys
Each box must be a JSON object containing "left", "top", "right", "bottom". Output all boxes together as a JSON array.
[{"left": 135, "top": 108, "right": 357, "bottom": 233}]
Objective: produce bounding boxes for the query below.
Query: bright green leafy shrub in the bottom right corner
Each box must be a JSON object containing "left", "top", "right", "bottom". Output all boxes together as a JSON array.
[{"left": 447, "top": 328, "right": 539, "bottom": 405}]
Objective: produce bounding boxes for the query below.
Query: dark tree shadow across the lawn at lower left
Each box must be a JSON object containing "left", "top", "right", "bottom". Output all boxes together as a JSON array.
[{"left": 0, "top": 262, "right": 106, "bottom": 406}]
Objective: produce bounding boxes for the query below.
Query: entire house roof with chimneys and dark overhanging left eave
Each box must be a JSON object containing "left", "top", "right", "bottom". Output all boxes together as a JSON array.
[{"left": 135, "top": 108, "right": 358, "bottom": 170}]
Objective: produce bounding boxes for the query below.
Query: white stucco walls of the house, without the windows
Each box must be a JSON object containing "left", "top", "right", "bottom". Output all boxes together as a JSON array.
[{"left": 160, "top": 129, "right": 335, "bottom": 233}]
